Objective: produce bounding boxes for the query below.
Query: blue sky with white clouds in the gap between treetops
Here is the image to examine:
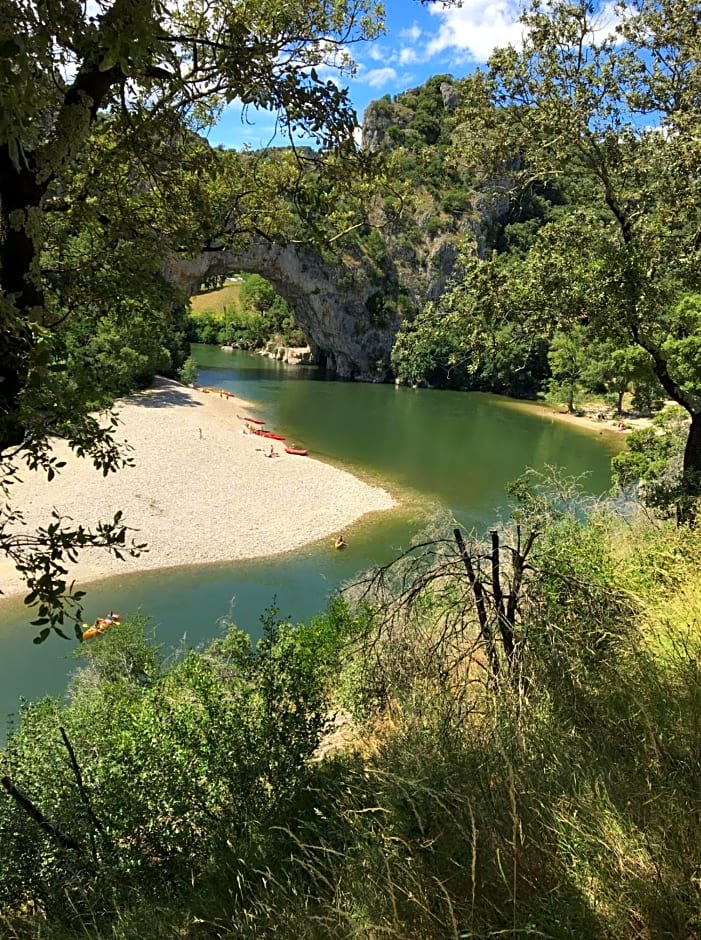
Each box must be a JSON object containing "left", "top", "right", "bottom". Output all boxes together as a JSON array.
[{"left": 204, "top": 0, "right": 521, "bottom": 148}]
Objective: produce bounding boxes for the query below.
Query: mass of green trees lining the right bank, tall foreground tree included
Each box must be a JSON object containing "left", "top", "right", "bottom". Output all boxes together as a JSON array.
[{"left": 382, "top": 0, "right": 701, "bottom": 517}]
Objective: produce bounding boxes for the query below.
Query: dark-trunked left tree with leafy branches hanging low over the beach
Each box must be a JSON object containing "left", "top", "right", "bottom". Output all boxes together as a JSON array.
[{"left": 0, "top": 0, "right": 456, "bottom": 632}]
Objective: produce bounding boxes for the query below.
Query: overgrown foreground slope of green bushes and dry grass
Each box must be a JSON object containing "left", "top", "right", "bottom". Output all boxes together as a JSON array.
[{"left": 0, "top": 481, "right": 701, "bottom": 940}]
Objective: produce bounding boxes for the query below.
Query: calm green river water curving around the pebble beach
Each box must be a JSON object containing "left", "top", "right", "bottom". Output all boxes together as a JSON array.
[{"left": 0, "top": 346, "right": 620, "bottom": 724}]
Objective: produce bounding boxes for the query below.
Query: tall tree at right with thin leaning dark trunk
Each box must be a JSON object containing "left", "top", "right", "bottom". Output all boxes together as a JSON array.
[{"left": 459, "top": 0, "right": 701, "bottom": 518}]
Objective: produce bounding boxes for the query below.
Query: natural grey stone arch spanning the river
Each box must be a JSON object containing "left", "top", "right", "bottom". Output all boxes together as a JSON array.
[{"left": 165, "top": 239, "right": 399, "bottom": 382}]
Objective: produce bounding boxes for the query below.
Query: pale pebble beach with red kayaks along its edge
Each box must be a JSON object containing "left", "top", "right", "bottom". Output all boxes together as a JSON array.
[{"left": 0, "top": 379, "right": 395, "bottom": 596}]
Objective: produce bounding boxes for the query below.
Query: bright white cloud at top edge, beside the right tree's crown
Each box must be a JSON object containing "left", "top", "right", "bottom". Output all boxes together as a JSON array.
[{"left": 426, "top": 0, "right": 523, "bottom": 62}]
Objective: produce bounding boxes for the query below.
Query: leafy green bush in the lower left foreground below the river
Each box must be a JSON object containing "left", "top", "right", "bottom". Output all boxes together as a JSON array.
[{"left": 0, "top": 610, "right": 338, "bottom": 921}]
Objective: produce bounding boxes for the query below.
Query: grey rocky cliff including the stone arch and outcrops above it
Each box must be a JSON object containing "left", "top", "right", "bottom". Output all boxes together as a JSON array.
[{"left": 167, "top": 77, "right": 508, "bottom": 381}]
